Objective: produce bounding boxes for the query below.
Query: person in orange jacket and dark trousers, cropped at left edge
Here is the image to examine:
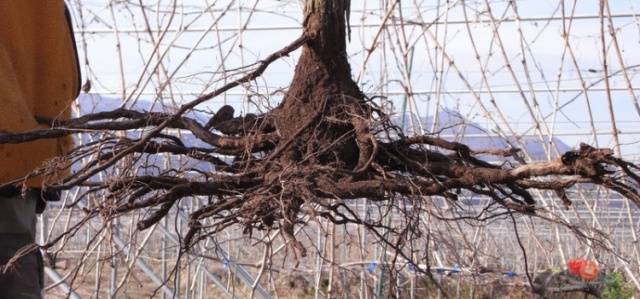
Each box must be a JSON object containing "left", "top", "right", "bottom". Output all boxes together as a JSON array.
[{"left": 0, "top": 0, "right": 80, "bottom": 298}]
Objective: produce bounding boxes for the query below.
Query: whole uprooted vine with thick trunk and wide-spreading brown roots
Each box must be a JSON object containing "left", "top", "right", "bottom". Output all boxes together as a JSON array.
[{"left": 0, "top": 0, "right": 640, "bottom": 278}]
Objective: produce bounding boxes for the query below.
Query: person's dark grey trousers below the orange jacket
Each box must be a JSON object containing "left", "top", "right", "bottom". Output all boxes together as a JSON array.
[{"left": 0, "top": 192, "right": 43, "bottom": 299}]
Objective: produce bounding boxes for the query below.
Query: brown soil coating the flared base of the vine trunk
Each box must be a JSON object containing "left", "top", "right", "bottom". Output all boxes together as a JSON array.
[{"left": 271, "top": 12, "right": 371, "bottom": 169}]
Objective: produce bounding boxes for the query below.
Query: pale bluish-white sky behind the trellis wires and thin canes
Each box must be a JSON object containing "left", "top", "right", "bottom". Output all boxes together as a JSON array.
[{"left": 69, "top": 0, "right": 640, "bottom": 158}]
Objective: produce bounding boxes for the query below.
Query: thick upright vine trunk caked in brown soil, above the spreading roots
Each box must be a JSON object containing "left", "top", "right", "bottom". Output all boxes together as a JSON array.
[{"left": 273, "top": 0, "right": 369, "bottom": 167}]
